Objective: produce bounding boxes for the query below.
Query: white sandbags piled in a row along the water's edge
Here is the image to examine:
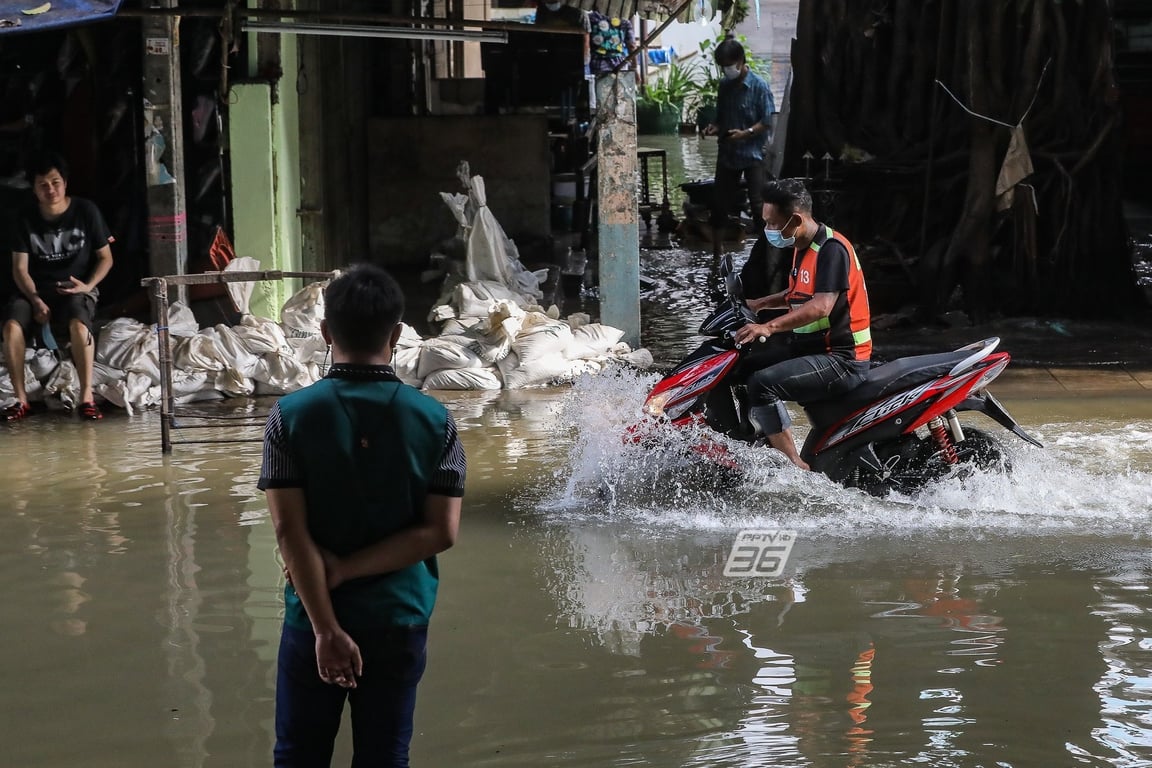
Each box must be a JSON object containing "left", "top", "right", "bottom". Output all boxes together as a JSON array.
[{"left": 0, "top": 276, "right": 652, "bottom": 413}]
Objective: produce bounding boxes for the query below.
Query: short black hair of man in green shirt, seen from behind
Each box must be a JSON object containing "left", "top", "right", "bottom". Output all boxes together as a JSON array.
[{"left": 324, "top": 264, "right": 404, "bottom": 355}]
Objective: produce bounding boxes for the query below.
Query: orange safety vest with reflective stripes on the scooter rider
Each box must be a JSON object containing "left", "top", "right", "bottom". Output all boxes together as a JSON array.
[{"left": 785, "top": 225, "right": 872, "bottom": 360}]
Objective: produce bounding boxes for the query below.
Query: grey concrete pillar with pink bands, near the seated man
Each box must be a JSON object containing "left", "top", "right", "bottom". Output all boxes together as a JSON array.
[{"left": 142, "top": 0, "right": 188, "bottom": 301}]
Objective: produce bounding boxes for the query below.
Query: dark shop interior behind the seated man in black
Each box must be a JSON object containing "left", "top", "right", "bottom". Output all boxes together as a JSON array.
[{"left": 0, "top": 17, "right": 227, "bottom": 319}]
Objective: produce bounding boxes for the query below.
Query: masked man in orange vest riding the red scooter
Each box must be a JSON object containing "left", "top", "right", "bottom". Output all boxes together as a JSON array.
[{"left": 735, "top": 178, "right": 872, "bottom": 470}]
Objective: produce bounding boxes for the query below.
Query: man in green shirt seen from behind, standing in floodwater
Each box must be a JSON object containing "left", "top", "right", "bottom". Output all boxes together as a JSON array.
[{"left": 259, "top": 266, "right": 465, "bottom": 768}]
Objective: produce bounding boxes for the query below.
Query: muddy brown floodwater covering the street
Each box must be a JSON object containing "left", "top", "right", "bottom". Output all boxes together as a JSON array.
[{"left": 0, "top": 251, "right": 1152, "bottom": 768}]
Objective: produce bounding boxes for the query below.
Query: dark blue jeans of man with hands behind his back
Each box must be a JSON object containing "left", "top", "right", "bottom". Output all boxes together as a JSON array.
[{"left": 274, "top": 626, "right": 427, "bottom": 768}]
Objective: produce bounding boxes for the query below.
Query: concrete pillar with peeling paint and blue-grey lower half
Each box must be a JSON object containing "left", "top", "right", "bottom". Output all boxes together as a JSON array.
[{"left": 596, "top": 71, "right": 641, "bottom": 347}]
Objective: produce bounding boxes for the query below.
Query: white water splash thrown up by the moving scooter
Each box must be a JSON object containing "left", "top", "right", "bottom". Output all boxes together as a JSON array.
[{"left": 543, "top": 370, "right": 1152, "bottom": 539}]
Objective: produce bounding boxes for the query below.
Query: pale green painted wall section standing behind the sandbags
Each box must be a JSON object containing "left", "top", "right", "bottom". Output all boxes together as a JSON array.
[{"left": 228, "top": 36, "right": 301, "bottom": 320}]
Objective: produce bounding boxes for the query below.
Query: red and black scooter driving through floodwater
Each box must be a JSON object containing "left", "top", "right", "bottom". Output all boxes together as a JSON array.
[{"left": 626, "top": 256, "right": 1043, "bottom": 494}]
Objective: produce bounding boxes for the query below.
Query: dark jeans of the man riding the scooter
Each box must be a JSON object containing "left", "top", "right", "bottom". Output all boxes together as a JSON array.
[{"left": 748, "top": 355, "right": 870, "bottom": 435}]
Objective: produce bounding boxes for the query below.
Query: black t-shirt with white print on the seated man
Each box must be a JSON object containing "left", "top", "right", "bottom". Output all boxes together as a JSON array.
[{"left": 12, "top": 197, "right": 112, "bottom": 292}]
